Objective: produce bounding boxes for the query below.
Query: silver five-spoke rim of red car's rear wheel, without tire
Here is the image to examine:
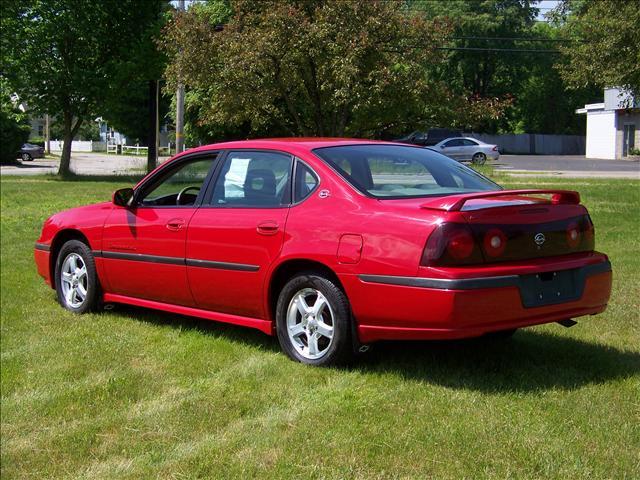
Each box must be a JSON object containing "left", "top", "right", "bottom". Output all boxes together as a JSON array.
[{"left": 287, "top": 288, "right": 335, "bottom": 360}]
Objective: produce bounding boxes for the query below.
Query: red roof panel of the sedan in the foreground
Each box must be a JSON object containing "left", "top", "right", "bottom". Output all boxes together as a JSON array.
[{"left": 178, "top": 137, "right": 402, "bottom": 157}]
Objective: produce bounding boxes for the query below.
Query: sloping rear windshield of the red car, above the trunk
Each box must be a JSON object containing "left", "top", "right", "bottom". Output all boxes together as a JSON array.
[{"left": 314, "top": 145, "right": 501, "bottom": 198}]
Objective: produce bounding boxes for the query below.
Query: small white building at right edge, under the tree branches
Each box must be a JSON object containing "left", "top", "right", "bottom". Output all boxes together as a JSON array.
[{"left": 576, "top": 88, "right": 640, "bottom": 159}]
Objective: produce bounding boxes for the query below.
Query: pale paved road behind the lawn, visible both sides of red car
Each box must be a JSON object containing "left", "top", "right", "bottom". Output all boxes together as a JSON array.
[{"left": 0, "top": 153, "right": 640, "bottom": 179}]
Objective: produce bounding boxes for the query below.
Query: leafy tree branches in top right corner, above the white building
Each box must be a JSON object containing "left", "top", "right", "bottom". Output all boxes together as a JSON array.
[{"left": 554, "top": 0, "right": 640, "bottom": 97}]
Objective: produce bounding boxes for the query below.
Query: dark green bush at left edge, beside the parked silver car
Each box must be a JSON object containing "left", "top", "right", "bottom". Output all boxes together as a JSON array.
[{"left": 0, "top": 76, "right": 31, "bottom": 163}]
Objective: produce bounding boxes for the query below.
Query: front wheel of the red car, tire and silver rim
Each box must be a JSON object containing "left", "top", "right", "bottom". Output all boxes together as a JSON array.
[{"left": 55, "top": 240, "right": 100, "bottom": 314}]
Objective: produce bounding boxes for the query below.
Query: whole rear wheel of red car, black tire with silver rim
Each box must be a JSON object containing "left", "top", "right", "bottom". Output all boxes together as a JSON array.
[{"left": 276, "top": 272, "right": 353, "bottom": 366}]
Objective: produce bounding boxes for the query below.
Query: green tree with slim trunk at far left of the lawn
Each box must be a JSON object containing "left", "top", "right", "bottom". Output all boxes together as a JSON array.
[{"left": 2, "top": 0, "right": 170, "bottom": 176}]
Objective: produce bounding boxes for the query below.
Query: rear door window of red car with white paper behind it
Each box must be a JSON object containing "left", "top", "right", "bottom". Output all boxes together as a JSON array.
[{"left": 211, "top": 151, "right": 292, "bottom": 207}]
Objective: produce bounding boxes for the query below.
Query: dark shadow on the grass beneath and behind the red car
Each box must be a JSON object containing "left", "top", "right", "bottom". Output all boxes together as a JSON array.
[{"left": 105, "top": 305, "right": 640, "bottom": 393}]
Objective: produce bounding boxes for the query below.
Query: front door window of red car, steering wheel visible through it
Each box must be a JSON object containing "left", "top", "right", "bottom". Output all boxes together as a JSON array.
[{"left": 138, "top": 156, "right": 216, "bottom": 206}]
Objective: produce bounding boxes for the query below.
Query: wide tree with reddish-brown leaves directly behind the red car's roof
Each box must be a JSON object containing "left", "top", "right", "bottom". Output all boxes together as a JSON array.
[{"left": 162, "top": 0, "right": 504, "bottom": 140}]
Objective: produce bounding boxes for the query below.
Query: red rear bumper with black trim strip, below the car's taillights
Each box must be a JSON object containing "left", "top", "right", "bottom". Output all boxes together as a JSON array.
[{"left": 343, "top": 255, "right": 612, "bottom": 343}]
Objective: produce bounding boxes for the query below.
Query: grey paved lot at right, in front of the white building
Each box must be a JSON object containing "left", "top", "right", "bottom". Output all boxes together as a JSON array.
[{"left": 493, "top": 155, "right": 640, "bottom": 179}]
